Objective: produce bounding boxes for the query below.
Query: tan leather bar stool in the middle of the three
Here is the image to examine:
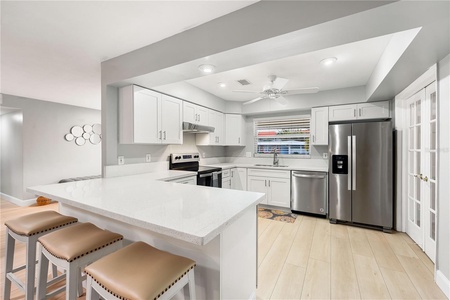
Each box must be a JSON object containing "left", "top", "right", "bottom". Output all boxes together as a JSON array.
[{"left": 37, "top": 223, "right": 123, "bottom": 300}]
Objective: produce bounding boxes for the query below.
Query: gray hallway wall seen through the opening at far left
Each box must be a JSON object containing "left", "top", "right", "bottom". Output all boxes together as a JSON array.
[{"left": 0, "top": 110, "right": 23, "bottom": 199}]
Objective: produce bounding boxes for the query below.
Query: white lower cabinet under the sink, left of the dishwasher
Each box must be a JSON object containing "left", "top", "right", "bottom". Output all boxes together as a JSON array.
[{"left": 247, "top": 169, "right": 291, "bottom": 208}]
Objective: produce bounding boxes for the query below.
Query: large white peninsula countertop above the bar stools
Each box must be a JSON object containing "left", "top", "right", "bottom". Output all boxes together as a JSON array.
[{"left": 27, "top": 171, "right": 265, "bottom": 245}]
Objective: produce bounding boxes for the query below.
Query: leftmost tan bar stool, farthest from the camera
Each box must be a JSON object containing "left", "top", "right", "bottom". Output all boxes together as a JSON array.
[{"left": 3, "top": 211, "right": 78, "bottom": 300}]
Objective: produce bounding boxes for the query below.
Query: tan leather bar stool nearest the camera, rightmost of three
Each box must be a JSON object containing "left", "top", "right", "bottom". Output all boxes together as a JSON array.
[{"left": 85, "top": 242, "right": 195, "bottom": 300}]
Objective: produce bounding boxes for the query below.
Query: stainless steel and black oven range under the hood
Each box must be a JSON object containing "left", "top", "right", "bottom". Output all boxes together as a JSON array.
[{"left": 169, "top": 153, "right": 222, "bottom": 188}]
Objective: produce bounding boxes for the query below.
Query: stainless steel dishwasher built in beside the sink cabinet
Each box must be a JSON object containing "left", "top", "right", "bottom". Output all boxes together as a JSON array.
[{"left": 291, "top": 171, "right": 328, "bottom": 215}]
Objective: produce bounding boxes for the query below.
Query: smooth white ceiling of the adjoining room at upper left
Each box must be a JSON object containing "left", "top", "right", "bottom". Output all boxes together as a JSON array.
[{"left": 0, "top": 0, "right": 257, "bottom": 109}]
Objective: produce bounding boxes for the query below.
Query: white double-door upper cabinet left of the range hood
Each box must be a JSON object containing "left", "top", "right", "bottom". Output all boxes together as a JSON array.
[{"left": 119, "top": 85, "right": 183, "bottom": 144}]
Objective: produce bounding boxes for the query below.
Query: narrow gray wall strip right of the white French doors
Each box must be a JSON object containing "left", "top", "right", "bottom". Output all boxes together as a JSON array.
[{"left": 436, "top": 55, "right": 450, "bottom": 284}]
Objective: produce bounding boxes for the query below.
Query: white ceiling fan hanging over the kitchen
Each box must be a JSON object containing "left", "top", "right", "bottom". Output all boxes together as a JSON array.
[{"left": 233, "top": 75, "right": 319, "bottom": 105}]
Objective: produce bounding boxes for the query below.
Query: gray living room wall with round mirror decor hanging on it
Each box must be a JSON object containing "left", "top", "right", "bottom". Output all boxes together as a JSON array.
[{"left": 2, "top": 95, "right": 101, "bottom": 199}]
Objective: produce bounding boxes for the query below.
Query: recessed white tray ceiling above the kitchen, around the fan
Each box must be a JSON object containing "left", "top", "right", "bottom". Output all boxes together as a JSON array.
[{"left": 187, "top": 34, "right": 392, "bottom": 101}]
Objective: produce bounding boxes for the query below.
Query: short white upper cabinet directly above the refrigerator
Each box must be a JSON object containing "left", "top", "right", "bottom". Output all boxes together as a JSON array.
[{"left": 328, "top": 101, "right": 390, "bottom": 122}]
